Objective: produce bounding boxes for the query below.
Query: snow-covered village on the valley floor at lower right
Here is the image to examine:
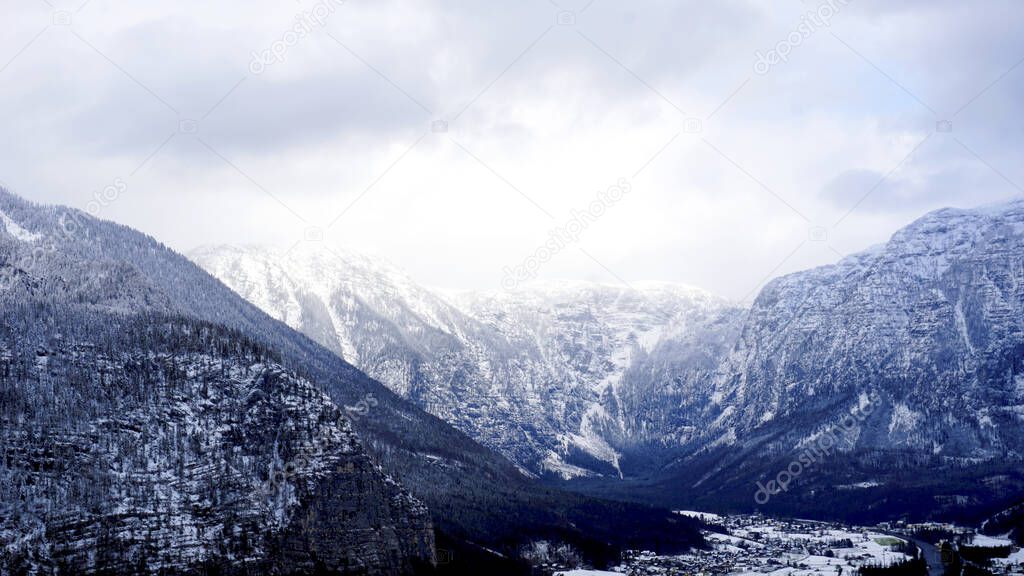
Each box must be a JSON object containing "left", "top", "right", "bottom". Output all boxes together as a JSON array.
[{"left": 555, "top": 510, "right": 1024, "bottom": 576}]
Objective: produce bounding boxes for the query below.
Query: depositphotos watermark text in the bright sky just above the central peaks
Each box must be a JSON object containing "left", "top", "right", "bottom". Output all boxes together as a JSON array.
[{"left": 502, "top": 178, "right": 633, "bottom": 290}]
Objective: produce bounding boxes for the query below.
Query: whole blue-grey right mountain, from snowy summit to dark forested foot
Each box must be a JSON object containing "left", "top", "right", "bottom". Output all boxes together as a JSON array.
[{"left": 622, "top": 201, "right": 1024, "bottom": 518}]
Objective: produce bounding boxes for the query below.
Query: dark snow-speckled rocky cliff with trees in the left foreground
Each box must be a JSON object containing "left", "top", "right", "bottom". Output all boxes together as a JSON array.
[{"left": 0, "top": 304, "right": 434, "bottom": 574}]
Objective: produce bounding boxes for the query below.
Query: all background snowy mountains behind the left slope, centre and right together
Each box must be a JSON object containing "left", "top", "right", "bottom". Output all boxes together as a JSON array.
[{"left": 193, "top": 201, "right": 1024, "bottom": 518}]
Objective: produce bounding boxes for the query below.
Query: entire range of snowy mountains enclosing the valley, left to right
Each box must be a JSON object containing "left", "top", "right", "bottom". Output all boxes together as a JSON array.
[{"left": 8, "top": 182, "right": 1024, "bottom": 574}]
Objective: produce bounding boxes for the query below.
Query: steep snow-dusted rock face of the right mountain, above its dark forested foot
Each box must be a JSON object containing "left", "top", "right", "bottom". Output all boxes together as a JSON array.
[{"left": 709, "top": 202, "right": 1024, "bottom": 459}]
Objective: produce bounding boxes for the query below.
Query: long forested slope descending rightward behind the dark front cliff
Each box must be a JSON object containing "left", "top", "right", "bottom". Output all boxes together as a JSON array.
[{"left": 0, "top": 192, "right": 701, "bottom": 568}]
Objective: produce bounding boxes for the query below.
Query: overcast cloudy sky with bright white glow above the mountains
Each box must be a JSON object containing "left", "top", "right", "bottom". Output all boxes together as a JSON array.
[{"left": 0, "top": 0, "right": 1024, "bottom": 299}]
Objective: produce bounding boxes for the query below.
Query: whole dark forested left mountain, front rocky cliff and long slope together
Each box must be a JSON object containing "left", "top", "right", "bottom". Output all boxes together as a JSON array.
[{"left": 0, "top": 191, "right": 701, "bottom": 574}]
